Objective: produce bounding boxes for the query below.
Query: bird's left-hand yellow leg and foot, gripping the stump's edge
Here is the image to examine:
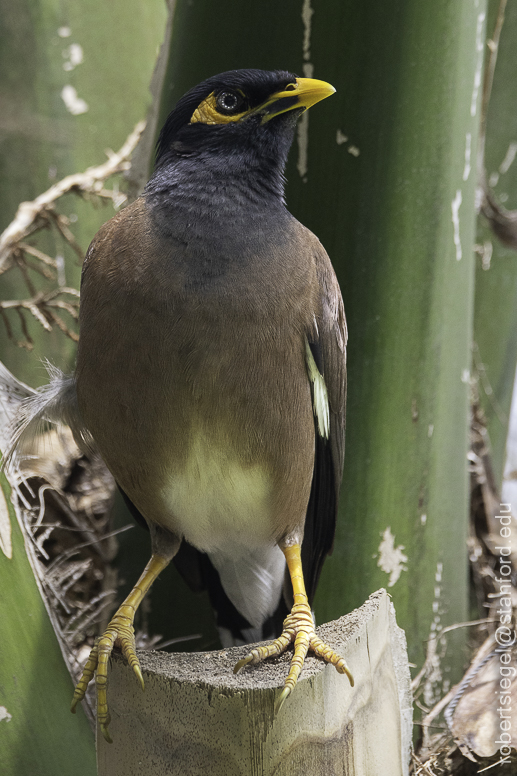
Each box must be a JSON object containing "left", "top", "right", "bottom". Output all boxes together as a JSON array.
[{"left": 71, "top": 554, "right": 169, "bottom": 744}]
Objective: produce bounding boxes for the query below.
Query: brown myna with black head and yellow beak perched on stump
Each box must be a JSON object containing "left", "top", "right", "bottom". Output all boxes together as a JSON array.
[{"left": 12, "top": 70, "right": 352, "bottom": 741}]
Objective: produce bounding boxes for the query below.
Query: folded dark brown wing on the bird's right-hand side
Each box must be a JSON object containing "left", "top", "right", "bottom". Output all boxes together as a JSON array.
[{"left": 302, "top": 242, "right": 347, "bottom": 603}]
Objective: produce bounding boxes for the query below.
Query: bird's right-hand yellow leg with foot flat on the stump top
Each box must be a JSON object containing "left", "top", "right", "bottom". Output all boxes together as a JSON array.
[{"left": 233, "top": 544, "right": 354, "bottom": 713}]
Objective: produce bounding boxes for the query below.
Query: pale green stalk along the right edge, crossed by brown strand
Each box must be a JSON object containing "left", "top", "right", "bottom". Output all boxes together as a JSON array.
[{"left": 474, "top": 0, "right": 517, "bottom": 487}]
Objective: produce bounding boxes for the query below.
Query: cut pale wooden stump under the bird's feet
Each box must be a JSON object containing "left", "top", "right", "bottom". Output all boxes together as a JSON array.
[{"left": 97, "top": 590, "right": 412, "bottom": 776}]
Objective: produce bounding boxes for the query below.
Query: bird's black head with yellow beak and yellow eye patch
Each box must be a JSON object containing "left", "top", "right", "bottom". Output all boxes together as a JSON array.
[{"left": 156, "top": 70, "right": 335, "bottom": 180}]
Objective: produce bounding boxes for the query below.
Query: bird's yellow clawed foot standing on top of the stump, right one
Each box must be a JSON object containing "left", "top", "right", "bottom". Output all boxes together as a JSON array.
[{"left": 233, "top": 601, "right": 354, "bottom": 713}]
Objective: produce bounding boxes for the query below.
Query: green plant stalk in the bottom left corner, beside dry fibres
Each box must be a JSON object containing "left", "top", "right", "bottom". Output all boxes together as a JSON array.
[{"left": 0, "top": 475, "right": 96, "bottom": 776}]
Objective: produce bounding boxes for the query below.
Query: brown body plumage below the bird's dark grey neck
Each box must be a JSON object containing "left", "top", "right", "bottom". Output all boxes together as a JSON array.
[{"left": 76, "top": 198, "right": 336, "bottom": 551}]
